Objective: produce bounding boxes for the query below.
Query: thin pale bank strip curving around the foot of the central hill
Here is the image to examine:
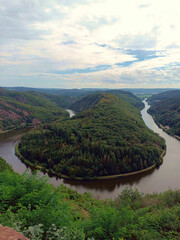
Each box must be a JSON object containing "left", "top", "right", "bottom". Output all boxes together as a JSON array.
[{"left": 15, "top": 143, "right": 166, "bottom": 181}]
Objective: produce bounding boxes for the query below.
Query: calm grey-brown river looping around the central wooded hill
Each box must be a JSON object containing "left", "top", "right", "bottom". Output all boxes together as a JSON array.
[{"left": 0, "top": 101, "right": 180, "bottom": 199}]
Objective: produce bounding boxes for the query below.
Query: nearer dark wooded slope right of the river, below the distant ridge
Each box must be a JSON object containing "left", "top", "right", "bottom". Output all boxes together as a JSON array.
[{"left": 148, "top": 96, "right": 180, "bottom": 140}]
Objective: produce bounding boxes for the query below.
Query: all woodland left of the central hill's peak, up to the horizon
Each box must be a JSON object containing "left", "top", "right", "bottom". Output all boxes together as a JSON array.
[{"left": 0, "top": 87, "right": 143, "bottom": 132}]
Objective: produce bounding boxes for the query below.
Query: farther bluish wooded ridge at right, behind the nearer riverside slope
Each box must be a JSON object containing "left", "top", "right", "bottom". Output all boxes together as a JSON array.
[{"left": 148, "top": 90, "right": 180, "bottom": 105}]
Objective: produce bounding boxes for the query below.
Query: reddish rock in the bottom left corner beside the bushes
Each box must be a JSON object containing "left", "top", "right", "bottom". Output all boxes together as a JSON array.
[{"left": 0, "top": 225, "right": 28, "bottom": 240}]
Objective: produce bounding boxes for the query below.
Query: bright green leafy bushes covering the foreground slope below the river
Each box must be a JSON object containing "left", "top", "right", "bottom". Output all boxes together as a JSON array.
[{"left": 0, "top": 161, "right": 180, "bottom": 240}]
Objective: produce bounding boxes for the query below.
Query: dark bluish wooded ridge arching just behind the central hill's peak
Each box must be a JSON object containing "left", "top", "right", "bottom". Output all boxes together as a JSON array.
[{"left": 70, "top": 90, "right": 144, "bottom": 112}]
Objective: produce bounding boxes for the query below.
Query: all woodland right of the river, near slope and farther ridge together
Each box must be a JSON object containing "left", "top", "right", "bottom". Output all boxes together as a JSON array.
[{"left": 148, "top": 90, "right": 180, "bottom": 140}]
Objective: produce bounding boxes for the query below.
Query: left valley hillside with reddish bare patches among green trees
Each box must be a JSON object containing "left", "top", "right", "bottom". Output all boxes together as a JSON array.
[{"left": 0, "top": 88, "right": 70, "bottom": 131}]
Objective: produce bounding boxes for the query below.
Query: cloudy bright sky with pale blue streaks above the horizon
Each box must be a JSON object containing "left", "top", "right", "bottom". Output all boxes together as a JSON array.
[{"left": 0, "top": 0, "right": 180, "bottom": 89}]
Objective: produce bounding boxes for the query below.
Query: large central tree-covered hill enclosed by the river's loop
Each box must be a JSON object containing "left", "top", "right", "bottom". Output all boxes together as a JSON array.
[{"left": 19, "top": 93, "right": 165, "bottom": 179}]
